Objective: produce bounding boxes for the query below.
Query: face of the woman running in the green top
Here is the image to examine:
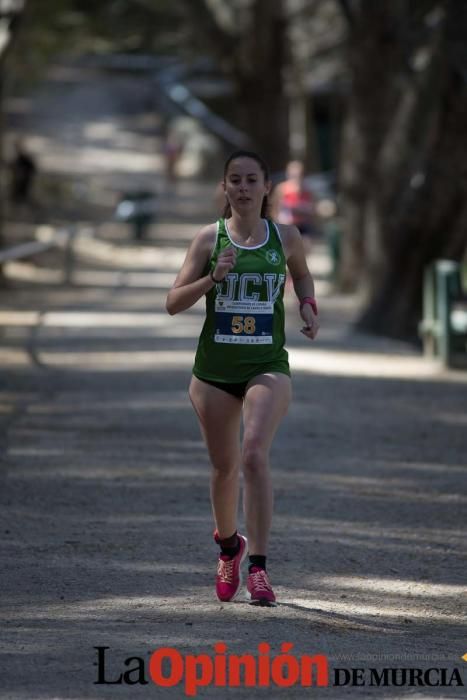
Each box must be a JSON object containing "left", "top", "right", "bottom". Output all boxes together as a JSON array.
[{"left": 223, "top": 157, "right": 271, "bottom": 214}]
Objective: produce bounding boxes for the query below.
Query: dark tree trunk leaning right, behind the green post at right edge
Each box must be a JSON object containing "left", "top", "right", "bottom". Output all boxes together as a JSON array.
[{"left": 358, "top": 0, "right": 467, "bottom": 340}]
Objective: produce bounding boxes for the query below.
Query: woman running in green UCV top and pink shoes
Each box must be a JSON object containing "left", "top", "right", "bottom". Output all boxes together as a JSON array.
[{"left": 167, "top": 151, "right": 319, "bottom": 606}]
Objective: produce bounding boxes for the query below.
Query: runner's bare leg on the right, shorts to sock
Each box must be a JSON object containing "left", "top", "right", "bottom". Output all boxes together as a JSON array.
[{"left": 242, "top": 373, "right": 292, "bottom": 555}]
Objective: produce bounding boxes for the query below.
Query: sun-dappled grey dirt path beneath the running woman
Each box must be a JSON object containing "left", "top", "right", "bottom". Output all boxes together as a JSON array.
[{"left": 0, "top": 63, "right": 467, "bottom": 700}]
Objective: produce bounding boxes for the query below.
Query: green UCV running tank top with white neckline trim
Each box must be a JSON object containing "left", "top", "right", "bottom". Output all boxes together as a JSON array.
[{"left": 193, "top": 219, "right": 290, "bottom": 383}]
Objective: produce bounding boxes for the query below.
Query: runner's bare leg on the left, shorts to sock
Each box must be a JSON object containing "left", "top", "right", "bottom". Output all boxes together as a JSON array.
[{"left": 189, "top": 377, "right": 242, "bottom": 539}]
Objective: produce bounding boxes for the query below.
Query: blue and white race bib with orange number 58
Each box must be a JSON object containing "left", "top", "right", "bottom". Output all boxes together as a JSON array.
[{"left": 214, "top": 299, "right": 274, "bottom": 345}]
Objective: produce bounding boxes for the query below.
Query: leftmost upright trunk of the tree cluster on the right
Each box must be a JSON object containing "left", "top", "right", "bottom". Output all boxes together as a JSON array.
[{"left": 339, "top": 2, "right": 403, "bottom": 291}]
